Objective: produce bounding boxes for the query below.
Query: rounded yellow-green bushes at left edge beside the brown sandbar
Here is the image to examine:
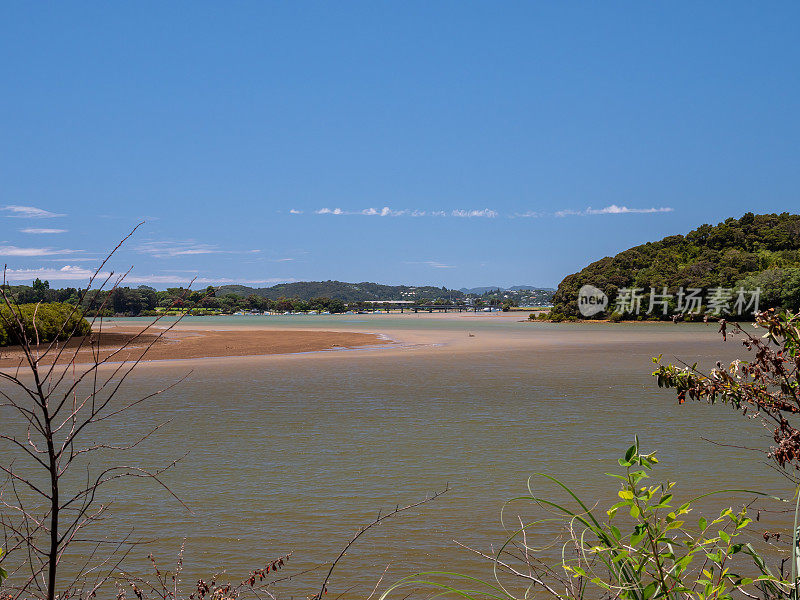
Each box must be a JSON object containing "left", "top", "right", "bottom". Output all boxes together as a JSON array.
[{"left": 0, "top": 302, "right": 91, "bottom": 346}]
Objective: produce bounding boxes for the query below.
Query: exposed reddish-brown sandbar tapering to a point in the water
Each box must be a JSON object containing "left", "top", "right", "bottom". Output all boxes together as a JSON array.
[{"left": 0, "top": 326, "right": 391, "bottom": 368}]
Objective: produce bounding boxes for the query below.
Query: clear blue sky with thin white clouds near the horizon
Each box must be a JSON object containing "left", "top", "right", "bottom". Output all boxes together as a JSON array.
[{"left": 0, "top": 1, "right": 800, "bottom": 287}]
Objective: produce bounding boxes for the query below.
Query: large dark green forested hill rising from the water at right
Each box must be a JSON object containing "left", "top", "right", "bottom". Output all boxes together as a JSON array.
[{"left": 551, "top": 213, "right": 800, "bottom": 320}]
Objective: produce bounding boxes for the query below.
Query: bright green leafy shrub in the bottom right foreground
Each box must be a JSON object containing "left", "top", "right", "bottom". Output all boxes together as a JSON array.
[{"left": 564, "top": 440, "right": 779, "bottom": 600}]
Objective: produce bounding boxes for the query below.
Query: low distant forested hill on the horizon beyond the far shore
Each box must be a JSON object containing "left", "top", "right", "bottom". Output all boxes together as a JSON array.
[{"left": 217, "top": 281, "right": 464, "bottom": 302}]
